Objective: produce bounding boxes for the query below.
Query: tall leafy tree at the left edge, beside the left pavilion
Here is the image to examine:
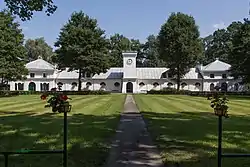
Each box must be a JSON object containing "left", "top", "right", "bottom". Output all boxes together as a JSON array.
[{"left": 0, "top": 11, "right": 28, "bottom": 88}]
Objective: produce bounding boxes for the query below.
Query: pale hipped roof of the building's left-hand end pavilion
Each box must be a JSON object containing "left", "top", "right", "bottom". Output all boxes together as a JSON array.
[{"left": 25, "top": 59, "right": 55, "bottom": 70}]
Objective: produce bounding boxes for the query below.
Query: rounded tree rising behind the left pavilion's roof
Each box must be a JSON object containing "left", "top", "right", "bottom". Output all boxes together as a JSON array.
[{"left": 25, "top": 37, "right": 54, "bottom": 63}]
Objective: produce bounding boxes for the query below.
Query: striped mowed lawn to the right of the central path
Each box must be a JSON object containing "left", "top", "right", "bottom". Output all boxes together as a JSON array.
[{"left": 134, "top": 95, "right": 250, "bottom": 167}]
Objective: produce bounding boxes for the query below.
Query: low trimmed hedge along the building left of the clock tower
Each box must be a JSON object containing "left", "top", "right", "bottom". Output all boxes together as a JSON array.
[{"left": 0, "top": 90, "right": 110, "bottom": 97}]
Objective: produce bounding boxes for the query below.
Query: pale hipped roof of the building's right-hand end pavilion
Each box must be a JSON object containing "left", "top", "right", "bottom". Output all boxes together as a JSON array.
[{"left": 202, "top": 59, "right": 231, "bottom": 71}]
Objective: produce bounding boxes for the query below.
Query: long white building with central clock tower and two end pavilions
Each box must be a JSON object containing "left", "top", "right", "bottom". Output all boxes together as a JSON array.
[{"left": 10, "top": 52, "right": 245, "bottom": 93}]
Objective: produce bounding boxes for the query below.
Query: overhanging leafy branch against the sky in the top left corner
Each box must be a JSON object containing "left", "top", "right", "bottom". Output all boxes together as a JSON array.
[{"left": 4, "top": 0, "right": 57, "bottom": 21}]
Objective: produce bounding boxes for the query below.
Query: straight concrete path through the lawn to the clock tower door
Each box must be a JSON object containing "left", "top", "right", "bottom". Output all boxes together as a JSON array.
[{"left": 106, "top": 95, "right": 163, "bottom": 167}]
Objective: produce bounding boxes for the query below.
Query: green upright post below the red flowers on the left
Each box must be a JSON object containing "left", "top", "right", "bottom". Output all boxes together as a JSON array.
[{"left": 63, "top": 110, "right": 68, "bottom": 167}]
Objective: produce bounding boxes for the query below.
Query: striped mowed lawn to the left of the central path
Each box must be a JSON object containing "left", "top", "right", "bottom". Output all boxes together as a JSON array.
[{"left": 0, "top": 94, "right": 125, "bottom": 167}]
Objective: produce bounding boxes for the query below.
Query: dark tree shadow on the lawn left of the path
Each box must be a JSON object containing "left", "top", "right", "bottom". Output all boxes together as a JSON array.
[{"left": 0, "top": 111, "right": 119, "bottom": 167}]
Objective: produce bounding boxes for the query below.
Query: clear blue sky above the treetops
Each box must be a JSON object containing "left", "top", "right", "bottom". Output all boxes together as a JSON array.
[{"left": 0, "top": 0, "right": 249, "bottom": 46}]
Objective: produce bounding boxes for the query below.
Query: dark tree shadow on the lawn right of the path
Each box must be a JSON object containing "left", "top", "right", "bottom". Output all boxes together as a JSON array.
[{"left": 142, "top": 112, "right": 250, "bottom": 167}]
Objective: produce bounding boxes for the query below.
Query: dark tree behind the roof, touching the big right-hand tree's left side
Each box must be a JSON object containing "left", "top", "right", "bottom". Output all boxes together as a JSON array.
[{"left": 143, "top": 35, "right": 165, "bottom": 67}]
